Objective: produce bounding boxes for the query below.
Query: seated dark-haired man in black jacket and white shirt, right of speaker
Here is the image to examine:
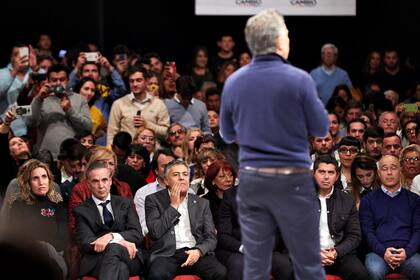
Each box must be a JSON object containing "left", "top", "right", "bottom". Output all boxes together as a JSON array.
[{"left": 314, "top": 155, "right": 369, "bottom": 280}]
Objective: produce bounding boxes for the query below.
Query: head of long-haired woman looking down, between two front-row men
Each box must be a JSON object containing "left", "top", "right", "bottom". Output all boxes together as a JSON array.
[{"left": 349, "top": 155, "right": 380, "bottom": 208}]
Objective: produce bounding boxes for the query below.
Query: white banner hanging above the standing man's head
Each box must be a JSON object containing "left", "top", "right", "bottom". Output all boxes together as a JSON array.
[{"left": 195, "top": 0, "right": 356, "bottom": 16}]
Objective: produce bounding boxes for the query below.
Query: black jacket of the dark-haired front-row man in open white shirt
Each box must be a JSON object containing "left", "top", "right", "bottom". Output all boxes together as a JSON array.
[{"left": 327, "top": 188, "right": 362, "bottom": 257}]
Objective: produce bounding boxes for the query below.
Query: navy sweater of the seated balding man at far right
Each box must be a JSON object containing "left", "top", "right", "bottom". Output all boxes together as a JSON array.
[{"left": 359, "top": 188, "right": 420, "bottom": 258}]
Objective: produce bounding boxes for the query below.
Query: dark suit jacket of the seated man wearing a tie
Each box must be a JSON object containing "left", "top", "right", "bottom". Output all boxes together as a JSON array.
[{"left": 73, "top": 195, "right": 143, "bottom": 275}]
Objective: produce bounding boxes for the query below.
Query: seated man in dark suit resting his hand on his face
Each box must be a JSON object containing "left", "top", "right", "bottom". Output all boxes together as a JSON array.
[{"left": 145, "top": 160, "right": 226, "bottom": 280}]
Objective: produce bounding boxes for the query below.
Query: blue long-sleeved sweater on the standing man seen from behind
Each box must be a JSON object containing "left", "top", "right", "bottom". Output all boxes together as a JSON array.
[{"left": 220, "top": 54, "right": 328, "bottom": 168}]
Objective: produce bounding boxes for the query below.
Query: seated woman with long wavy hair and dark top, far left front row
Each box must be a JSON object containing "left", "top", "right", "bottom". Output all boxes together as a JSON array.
[{"left": 9, "top": 159, "right": 68, "bottom": 278}]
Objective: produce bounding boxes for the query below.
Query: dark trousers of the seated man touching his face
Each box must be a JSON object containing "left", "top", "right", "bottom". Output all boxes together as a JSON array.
[{"left": 147, "top": 248, "right": 226, "bottom": 280}]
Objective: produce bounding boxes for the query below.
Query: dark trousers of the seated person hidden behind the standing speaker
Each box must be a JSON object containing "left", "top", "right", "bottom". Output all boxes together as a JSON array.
[{"left": 216, "top": 250, "right": 293, "bottom": 280}]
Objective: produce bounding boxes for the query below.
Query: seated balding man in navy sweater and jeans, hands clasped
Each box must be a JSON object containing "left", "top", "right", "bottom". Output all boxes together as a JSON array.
[{"left": 359, "top": 155, "right": 420, "bottom": 280}]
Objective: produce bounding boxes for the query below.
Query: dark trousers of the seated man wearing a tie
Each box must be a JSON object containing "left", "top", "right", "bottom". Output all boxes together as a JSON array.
[{"left": 91, "top": 243, "right": 142, "bottom": 280}]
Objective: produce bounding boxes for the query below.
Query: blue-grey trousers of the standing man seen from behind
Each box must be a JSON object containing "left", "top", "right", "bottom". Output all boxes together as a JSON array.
[{"left": 237, "top": 169, "right": 325, "bottom": 280}]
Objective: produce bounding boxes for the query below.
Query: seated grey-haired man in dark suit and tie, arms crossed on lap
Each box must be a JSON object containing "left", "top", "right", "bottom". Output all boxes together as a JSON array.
[{"left": 73, "top": 161, "right": 143, "bottom": 279}]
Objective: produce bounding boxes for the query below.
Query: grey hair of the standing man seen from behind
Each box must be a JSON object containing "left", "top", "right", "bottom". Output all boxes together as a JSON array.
[{"left": 245, "top": 9, "right": 286, "bottom": 56}]
